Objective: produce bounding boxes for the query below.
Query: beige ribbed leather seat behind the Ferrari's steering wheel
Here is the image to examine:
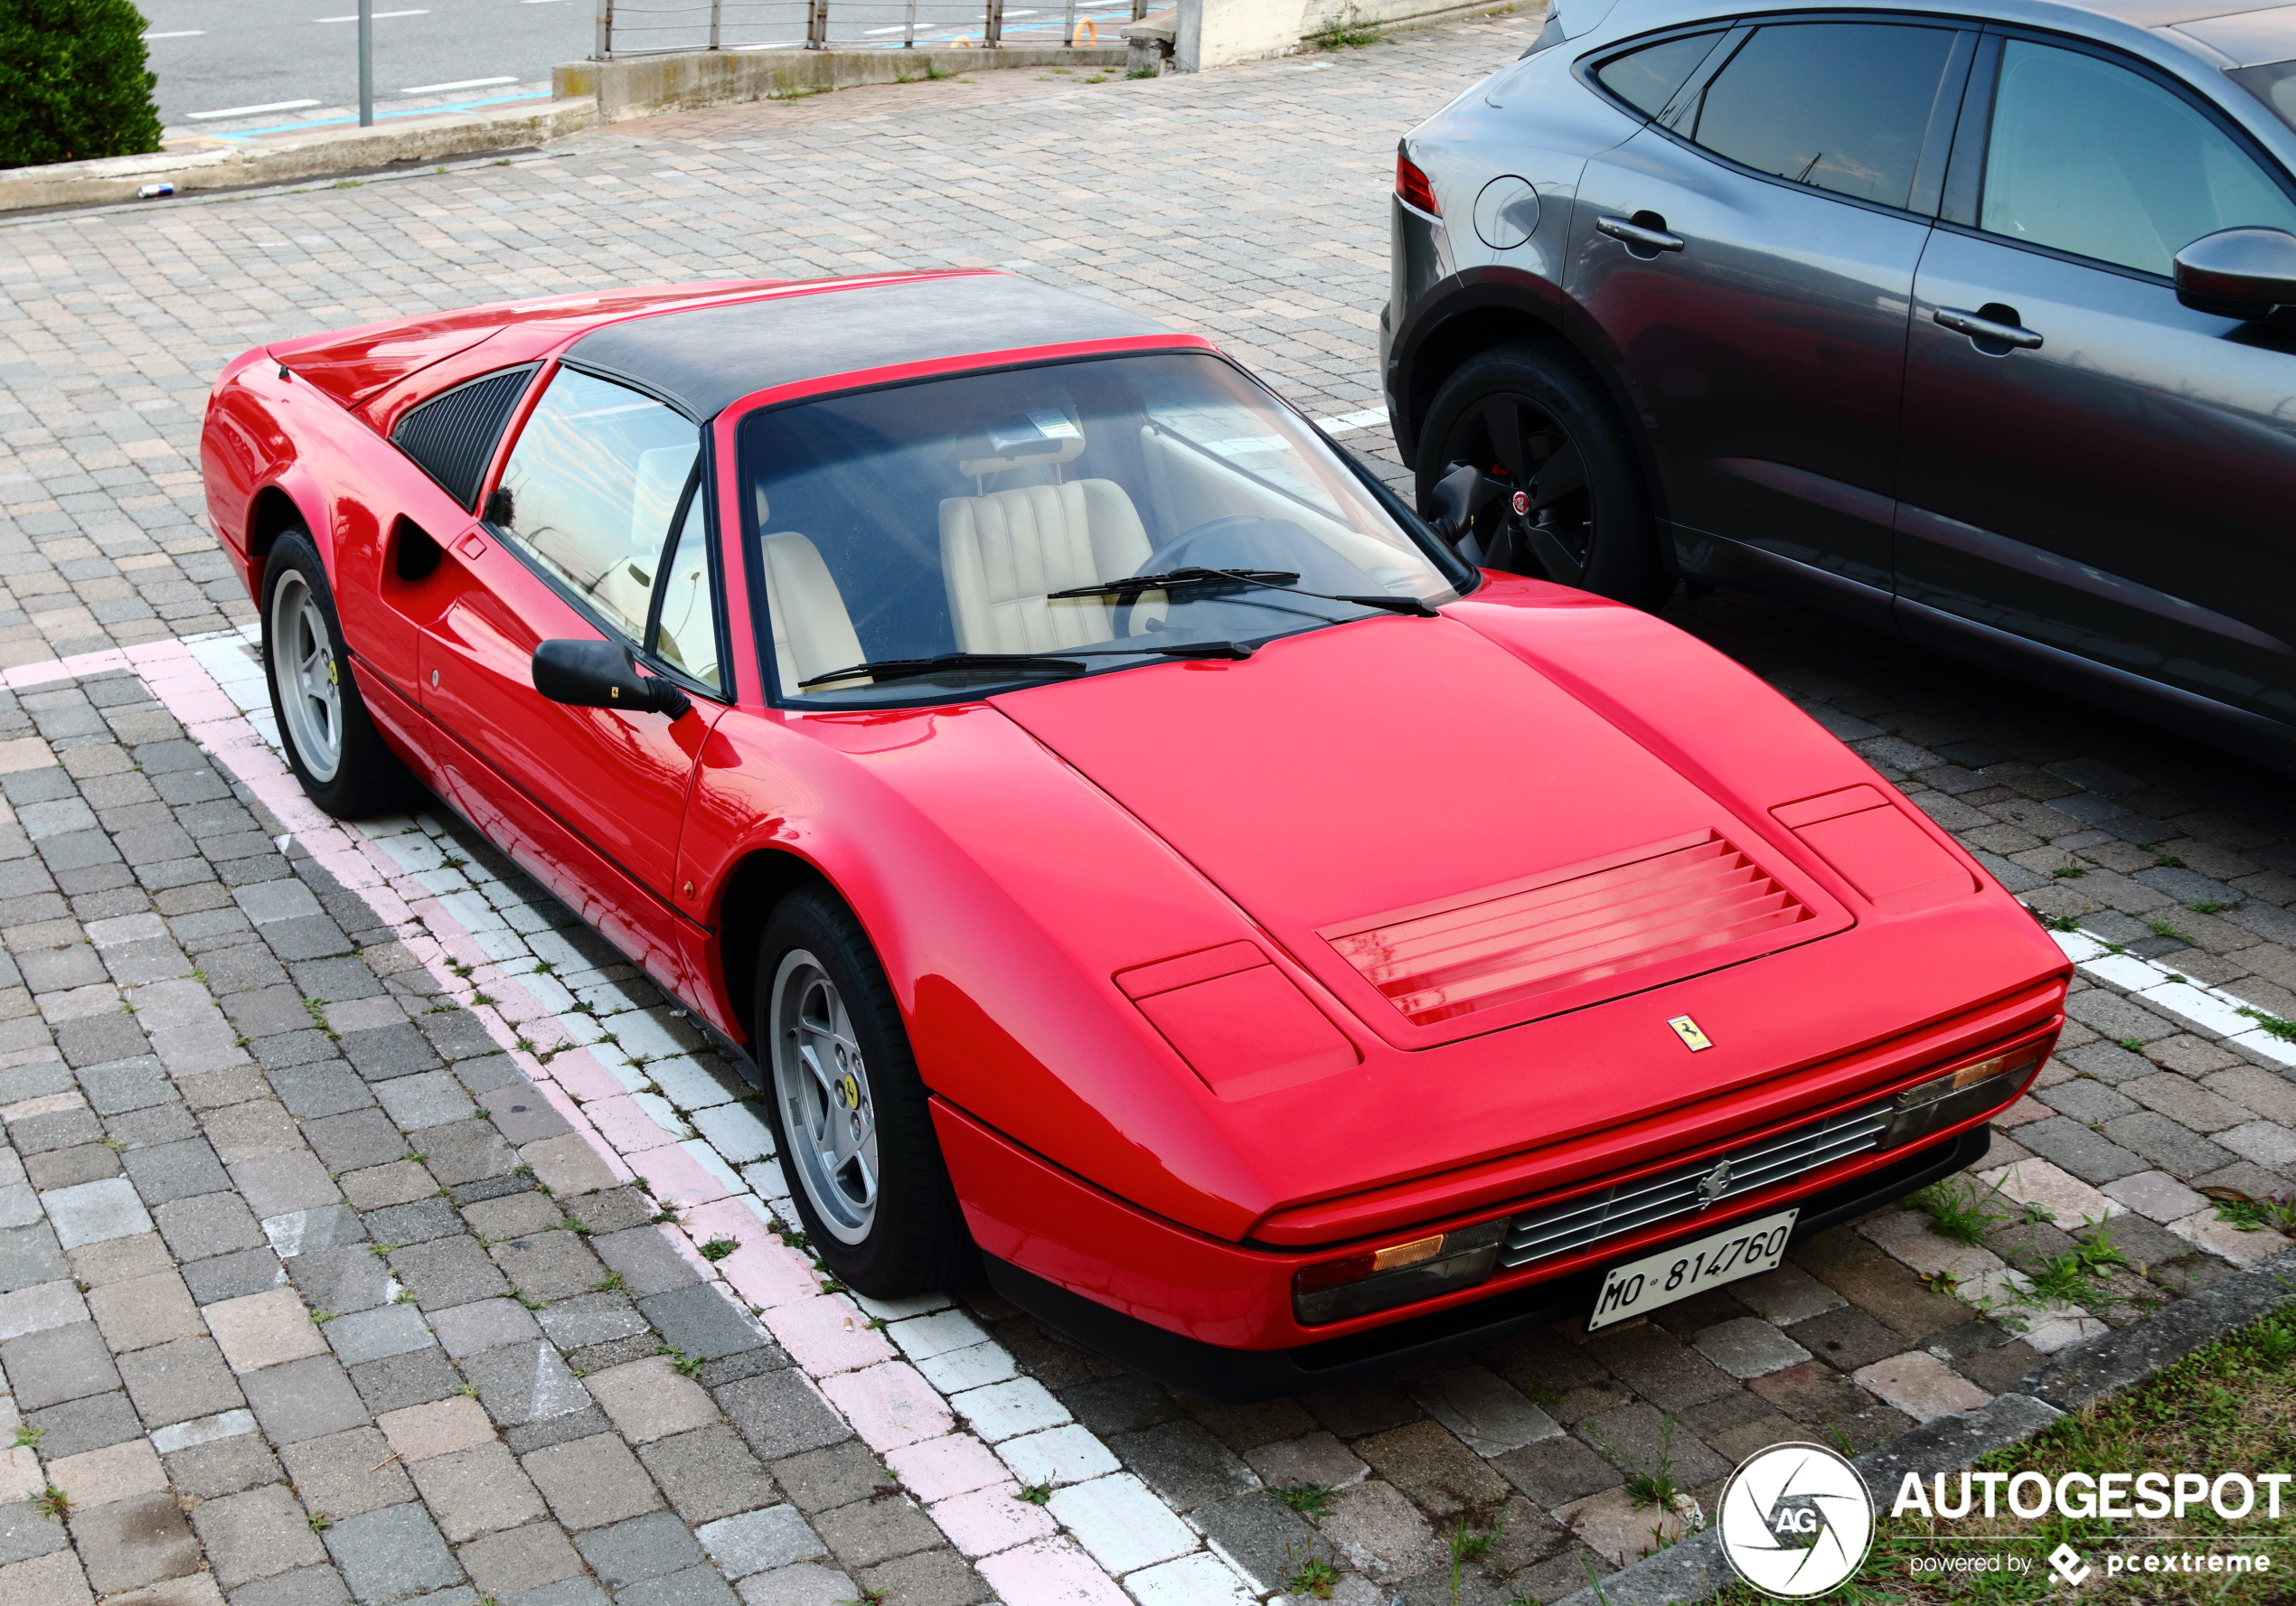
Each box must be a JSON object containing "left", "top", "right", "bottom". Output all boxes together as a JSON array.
[{"left": 941, "top": 480, "right": 1151, "bottom": 652}]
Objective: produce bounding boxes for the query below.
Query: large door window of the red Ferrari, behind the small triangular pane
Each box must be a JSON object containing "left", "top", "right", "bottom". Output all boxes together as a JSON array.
[{"left": 494, "top": 370, "right": 701, "bottom": 643}]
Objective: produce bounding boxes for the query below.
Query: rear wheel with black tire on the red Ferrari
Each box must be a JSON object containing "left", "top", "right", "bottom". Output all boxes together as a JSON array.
[{"left": 262, "top": 528, "right": 420, "bottom": 819}]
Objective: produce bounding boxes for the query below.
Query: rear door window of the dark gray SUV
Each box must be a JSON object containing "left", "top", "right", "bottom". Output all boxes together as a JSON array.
[{"left": 1685, "top": 23, "right": 1954, "bottom": 206}]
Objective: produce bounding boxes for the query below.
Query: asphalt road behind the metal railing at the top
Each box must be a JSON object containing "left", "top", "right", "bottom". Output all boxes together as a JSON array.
[{"left": 142, "top": 0, "right": 1132, "bottom": 128}]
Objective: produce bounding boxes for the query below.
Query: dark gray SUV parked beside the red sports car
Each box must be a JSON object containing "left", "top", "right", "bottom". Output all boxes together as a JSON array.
[{"left": 1382, "top": 0, "right": 2296, "bottom": 768}]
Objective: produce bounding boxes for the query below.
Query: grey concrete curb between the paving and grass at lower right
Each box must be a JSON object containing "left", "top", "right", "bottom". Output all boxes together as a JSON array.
[{"left": 1557, "top": 1251, "right": 2296, "bottom": 1606}]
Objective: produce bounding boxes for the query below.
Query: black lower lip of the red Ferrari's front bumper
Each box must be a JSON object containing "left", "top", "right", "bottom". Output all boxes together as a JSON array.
[{"left": 983, "top": 1126, "right": 1993, "bottom": 1404}]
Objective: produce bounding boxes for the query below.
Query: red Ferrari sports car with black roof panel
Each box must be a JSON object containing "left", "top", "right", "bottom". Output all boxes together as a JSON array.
[{"left": 202, "top": 273, "right": 2066, "bottom": 1400}]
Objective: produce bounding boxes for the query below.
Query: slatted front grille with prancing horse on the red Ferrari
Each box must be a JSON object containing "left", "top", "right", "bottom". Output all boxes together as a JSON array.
[{"left": 1500, "top": 1104, "right": 1889, "bottom": 1266}]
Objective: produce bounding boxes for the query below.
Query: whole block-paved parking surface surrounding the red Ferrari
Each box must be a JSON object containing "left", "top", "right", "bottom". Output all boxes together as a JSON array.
[{"left": 0, "top": 18, "right": 2296, "bottom": 1606}]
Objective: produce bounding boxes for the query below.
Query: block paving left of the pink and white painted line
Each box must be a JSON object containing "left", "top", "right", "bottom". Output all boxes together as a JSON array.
[{"left": 0, "top": 656, "right": 983, "bottom": 1606}]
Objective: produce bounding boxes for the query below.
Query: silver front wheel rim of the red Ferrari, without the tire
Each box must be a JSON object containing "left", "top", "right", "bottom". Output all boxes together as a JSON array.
[{"left": 769, "top": 947, "right": 880, "bottom": 1244}]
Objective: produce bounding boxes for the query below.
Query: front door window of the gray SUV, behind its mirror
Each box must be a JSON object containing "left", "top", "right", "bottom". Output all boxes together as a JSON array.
[{"left": 1977, "top": 39, "right": 2296, "bottom": 276}]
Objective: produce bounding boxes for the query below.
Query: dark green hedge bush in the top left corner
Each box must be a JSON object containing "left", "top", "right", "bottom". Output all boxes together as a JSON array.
[{"left": 0, "top": 0, "right": 158, "bottom": 167}]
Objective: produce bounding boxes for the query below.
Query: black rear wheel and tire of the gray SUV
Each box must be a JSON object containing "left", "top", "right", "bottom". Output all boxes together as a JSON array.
[{"left": 1416, "top": 342, "right": 1674, "bottom": 608}]
